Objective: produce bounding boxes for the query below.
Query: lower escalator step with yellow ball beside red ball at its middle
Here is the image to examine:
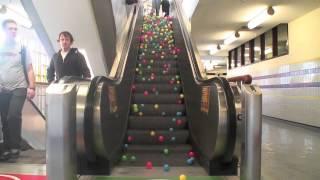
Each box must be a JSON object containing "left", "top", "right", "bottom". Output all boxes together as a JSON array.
[{"left": 127, "top": 129, "right": 189, "bottom": 145}]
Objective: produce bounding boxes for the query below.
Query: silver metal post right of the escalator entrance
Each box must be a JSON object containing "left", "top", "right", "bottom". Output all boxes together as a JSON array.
[{"left": 240, "top": 84, "right": 262, "bottom": 180}]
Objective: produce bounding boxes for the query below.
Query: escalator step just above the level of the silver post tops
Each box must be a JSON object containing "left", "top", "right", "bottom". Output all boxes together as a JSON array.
[{"left": 135, "top": 75, "right": 180, "bottom": 84}]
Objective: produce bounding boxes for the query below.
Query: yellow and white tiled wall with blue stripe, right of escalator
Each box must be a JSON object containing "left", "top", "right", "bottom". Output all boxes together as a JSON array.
[{"left": 228, "top": 8, "right": 320, "bottom": 127}]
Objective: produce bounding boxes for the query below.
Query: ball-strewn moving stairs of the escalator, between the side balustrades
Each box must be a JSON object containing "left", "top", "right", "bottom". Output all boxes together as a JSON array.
[{"left": 120, "top": 16, "right": 194, "bottom": 168}]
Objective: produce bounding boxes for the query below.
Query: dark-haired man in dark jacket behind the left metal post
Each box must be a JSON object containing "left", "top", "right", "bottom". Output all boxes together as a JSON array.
[{"left": 47, "top": 31, "right": 91, "bottom": 83}]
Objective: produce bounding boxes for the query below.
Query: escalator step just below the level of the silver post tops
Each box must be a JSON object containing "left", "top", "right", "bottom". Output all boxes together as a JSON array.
[{"left": 134, "top": 84, "right": 182, "bottom": 94}]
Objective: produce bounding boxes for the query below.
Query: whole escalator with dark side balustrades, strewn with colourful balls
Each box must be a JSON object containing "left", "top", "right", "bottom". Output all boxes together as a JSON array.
[{"left": 47, "top": 1, "right": 262, "bottom": 180}]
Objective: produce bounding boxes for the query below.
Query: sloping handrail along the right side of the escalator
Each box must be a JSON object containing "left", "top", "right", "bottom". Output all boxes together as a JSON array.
[{"left": 173, "top": 0, "right": 207, "bottom": 83}]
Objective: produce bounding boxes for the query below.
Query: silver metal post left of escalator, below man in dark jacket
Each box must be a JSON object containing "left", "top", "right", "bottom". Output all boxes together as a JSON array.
[{"left": 46, "top": 84, "right": 77, "bottom": 180}]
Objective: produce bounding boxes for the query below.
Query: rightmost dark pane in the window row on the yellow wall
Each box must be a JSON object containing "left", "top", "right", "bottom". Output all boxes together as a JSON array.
[{"left": 278, "top": 24, "right": 289, "bottom": 56}]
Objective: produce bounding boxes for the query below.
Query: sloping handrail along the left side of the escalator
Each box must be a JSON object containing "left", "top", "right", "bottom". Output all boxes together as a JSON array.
[{"left": 106, "top": 3, "right": 142, "bottom": 84}]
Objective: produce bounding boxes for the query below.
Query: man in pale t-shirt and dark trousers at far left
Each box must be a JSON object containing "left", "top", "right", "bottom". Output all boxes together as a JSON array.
[{"left": 0, "top": 19, "right": 35, "bottom": 161}]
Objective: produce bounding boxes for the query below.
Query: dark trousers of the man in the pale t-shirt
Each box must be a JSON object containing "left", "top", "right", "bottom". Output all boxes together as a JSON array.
[{"left": 0, "top": 88, "right": 27, "bottom": 150}]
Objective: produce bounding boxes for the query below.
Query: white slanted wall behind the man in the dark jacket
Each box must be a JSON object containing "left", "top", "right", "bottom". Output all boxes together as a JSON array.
[{"left": 28, "top": 0, "right": 107, "bottom": 76}]
